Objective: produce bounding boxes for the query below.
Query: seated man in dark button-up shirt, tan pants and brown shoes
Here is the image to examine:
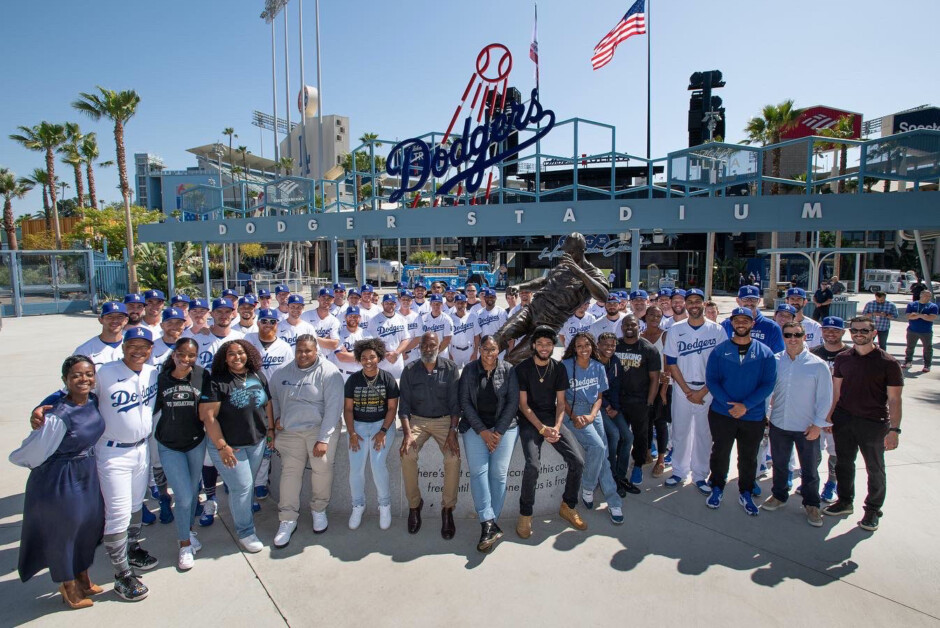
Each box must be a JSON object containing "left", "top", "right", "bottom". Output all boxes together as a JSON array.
[{"left": 398, "top": 331, "right": 460, "bottom": 539}]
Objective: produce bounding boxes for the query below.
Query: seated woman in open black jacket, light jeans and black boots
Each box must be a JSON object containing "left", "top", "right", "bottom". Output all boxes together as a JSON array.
[{"left": 459, "top": 335, "right": 519, "bottom": 553}]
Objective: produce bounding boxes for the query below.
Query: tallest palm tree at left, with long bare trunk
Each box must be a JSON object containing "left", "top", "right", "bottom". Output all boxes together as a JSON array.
[{"left": 72, "top": 85, "right": 140, "bottom": 292}]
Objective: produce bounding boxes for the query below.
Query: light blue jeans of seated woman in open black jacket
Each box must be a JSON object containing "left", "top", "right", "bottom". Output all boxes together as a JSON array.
[{"left": 463, "top": 427, "right": 519, "bottom": 523}]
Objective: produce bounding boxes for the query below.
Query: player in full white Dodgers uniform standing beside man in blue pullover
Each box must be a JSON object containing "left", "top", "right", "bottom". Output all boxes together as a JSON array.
[{"left": 663, "top": 289, "right": 728, "bottom": 495}]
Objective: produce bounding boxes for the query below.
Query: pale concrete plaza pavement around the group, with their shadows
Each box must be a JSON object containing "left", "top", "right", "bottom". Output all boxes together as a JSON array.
[{"left": 0, "top": 296, "right": 940, "bottom": 628}]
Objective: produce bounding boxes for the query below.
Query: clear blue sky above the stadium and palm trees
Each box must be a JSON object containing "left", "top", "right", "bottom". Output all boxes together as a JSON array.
[{"left": 0, "top": 0, "right": 940, "bottom": 214}]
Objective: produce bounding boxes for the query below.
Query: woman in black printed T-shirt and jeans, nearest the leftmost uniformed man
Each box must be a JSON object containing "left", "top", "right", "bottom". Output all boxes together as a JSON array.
[{"left": 153, "top": 338, "right": 206, "bottom": 571}]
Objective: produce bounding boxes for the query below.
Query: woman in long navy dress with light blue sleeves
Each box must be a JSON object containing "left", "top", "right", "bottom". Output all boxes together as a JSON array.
[{"left": 10, "top": 355, "right": 104, "bottom": 608}]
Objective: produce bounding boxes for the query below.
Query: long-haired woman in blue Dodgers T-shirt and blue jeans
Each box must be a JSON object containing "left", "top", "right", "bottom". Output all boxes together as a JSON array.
[{"left": 561, "top": 332, "right": 623, "bottom": 525}]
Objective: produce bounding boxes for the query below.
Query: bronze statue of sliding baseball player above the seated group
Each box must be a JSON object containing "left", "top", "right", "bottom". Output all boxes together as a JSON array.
[{"left": 496, "top": 232, "right": 610, "bottom": 364}]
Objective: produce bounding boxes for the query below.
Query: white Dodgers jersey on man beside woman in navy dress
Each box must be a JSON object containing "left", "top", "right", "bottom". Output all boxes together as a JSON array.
[{"left": 95, "top": 360, "right": 157, "bottom": 443}]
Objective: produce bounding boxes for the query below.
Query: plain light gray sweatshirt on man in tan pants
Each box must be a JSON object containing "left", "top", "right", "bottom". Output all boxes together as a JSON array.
[{"left": 268, "top": 356, "right": 343, "bottom": 443}]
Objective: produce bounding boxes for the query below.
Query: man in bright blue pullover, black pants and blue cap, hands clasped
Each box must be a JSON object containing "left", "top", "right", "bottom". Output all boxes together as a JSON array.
[{"left": 705, "top": 306, "right": 779, "bottom": 516}]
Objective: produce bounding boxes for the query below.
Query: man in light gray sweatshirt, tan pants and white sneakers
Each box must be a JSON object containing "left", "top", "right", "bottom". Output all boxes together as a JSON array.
[{"left": 268, "top": 334, "right": 343, "bottom": 548}]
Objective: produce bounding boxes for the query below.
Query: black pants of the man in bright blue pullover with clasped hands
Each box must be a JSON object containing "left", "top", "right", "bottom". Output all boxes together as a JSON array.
[{"left": 708, "top": 410, "right": 764, "bottom": 493}]
